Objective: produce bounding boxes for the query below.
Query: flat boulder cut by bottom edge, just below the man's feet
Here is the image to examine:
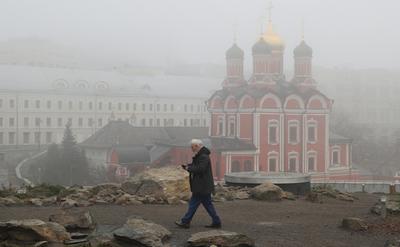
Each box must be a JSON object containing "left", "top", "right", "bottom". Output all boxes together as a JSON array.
[{"left": 187, "top": 230, "right": 255, "bottom": 247}]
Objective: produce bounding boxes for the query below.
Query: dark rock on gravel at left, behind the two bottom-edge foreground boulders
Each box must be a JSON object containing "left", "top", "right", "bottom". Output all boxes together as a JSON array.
[{"left": 49, "top": 210, "right": 95, "bottom": 230}]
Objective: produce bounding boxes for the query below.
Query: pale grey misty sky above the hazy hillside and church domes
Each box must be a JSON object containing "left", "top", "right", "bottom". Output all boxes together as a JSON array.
[{"left": 0, "top": 0, "right": 400, "bottom": 68}]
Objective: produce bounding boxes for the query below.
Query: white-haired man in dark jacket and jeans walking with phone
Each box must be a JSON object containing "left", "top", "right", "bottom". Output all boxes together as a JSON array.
[{"left": 175, "top": 139, "right": 221, "bottom": 228}]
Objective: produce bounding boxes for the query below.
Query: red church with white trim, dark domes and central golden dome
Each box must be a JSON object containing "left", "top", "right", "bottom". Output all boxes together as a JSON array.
[{"left": 208, "top": 21, "right": 357, "bottom": 179}]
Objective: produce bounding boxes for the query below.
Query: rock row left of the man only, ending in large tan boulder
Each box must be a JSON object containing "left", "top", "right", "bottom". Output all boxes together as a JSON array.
[{"left": 0, "top": 167, "right": 190, "bottom": 208}]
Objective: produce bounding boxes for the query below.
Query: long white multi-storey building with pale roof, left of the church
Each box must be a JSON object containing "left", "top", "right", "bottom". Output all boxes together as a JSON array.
[{"left": 0, "top": 66, "right": 215, "bottom": 146}]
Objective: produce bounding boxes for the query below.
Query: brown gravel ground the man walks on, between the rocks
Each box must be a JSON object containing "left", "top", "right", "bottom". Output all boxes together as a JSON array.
[{"left": 0, "top": 194, "right": 396, "bottom": 247}]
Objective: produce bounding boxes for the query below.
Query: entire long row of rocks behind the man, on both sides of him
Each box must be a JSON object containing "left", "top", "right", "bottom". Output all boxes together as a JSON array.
[{"left": 0, "top": 167, "right": 308, "bottom": 209}]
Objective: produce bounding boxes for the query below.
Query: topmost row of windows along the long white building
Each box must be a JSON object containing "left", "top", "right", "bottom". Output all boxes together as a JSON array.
[{"left": 0, "top": 99, "right": 206, "bottom": 112}]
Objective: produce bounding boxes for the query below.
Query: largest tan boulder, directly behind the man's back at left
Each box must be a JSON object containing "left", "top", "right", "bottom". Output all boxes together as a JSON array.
[{"left": 121, "top": 167, "right": 190, "bottom": 203}]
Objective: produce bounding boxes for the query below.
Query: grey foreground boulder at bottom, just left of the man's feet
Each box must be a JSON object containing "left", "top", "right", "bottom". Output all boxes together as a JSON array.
[{"left": 113, "top": 217, "right": 171, "bottom": 247}]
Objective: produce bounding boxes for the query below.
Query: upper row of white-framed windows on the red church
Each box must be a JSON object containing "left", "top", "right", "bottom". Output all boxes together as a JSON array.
[{"left": 217, "top": 117, "right": 317, "bottom": 144}]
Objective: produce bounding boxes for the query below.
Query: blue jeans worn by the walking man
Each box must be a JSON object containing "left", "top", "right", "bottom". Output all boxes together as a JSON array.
[{"left": 181, "top": 194, "right": 221, "bottom": 224}]
